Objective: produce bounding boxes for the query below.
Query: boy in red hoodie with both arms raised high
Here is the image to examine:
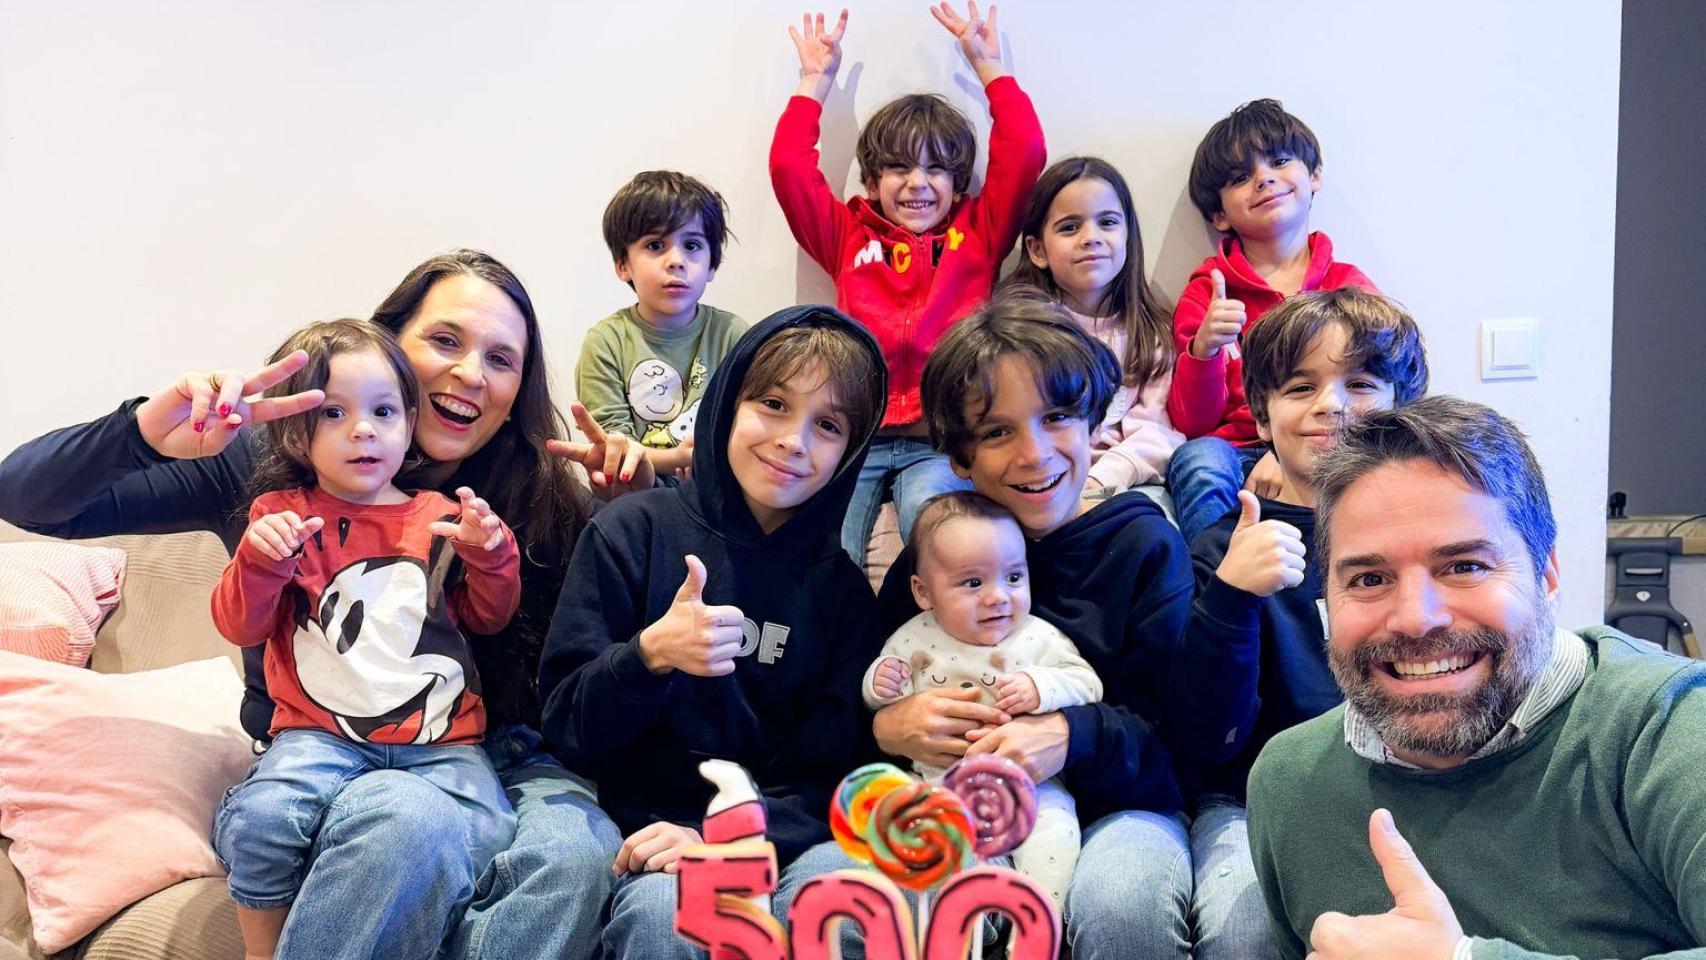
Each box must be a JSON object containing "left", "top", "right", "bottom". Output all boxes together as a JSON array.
[{"left": 769, "top": 2, "right": 1046, "bottom": 566}]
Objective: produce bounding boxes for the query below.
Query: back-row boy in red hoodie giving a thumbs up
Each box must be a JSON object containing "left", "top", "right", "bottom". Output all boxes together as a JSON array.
[{"left": 1167, "top": 101, "right": 1378, "bottom": 542}]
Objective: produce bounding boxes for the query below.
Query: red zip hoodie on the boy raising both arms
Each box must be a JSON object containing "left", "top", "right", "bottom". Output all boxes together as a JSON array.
[{"left": 769, "top": 77, "right": 1047, "bottom": 426}]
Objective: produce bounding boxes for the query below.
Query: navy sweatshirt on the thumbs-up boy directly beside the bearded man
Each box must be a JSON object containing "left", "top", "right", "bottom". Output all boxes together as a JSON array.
[{"left": 1172, "top": 500, "right": 1343, "bottom": 800}]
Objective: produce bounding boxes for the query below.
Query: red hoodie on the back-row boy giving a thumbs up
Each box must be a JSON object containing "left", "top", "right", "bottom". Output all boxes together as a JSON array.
[{"left": 1167, "top": 232, "right": 1380, "bottom": 443}]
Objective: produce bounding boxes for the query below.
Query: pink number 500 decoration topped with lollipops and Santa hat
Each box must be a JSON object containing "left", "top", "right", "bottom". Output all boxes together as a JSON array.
[{"left": 676, "top": 755, "right": 1061, "bottom": 960}]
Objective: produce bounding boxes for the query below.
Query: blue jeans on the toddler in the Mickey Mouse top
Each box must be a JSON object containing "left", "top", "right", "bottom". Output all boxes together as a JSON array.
[{"left": 213, "top": 730, "right": 515, "bottom": 951}]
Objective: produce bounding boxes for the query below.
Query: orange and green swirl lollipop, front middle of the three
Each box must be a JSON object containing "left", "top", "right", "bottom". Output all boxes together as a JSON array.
[{"left": 865, "top": 781, "right": 972, "bottom": 890}]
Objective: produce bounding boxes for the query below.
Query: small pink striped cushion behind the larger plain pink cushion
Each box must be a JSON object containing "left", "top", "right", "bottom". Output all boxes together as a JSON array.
[{"left": 0, "top": 544, "right": 125, "bottom": 667}]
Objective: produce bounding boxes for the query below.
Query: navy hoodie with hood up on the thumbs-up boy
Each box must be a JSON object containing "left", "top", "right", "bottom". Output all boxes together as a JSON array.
[{"left": 539, "top": 305, "right": 885, "bottom": 861}]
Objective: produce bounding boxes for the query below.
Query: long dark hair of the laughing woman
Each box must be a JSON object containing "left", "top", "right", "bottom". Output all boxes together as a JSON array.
[{"left": 374, "top": 249, "right": 592, "bottom": 570}]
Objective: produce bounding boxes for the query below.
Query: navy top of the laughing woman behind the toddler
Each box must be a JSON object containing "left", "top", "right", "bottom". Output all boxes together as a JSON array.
[{"left": 0, "top": 397, "right": 566, "bottom": 742}]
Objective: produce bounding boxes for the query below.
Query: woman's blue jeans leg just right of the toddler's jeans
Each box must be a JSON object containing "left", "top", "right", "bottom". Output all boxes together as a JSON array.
[{"left": 449, "top": 726, "right": 623, "bottom": 960}]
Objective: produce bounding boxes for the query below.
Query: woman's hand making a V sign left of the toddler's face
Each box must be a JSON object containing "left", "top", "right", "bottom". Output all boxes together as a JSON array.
[{"left": 136, "top": 350, "right": 326, "bottom": 460}]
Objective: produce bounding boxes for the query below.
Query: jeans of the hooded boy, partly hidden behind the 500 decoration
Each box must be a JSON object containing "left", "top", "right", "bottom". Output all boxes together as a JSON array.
[{"left": 601, "top": 841, "right": 865, "bottom": 960}]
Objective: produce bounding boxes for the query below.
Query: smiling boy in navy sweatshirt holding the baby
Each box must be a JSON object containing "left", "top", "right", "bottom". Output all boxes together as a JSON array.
[{"left": 875, "top": 297, "right": 1192, "bottom": 960}]
